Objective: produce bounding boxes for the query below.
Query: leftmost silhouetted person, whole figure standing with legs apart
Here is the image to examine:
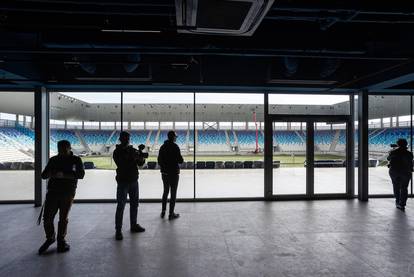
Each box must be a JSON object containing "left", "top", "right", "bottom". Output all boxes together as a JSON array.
[{"left": 39, "top": 140, "right": 85, "bottom": 254}]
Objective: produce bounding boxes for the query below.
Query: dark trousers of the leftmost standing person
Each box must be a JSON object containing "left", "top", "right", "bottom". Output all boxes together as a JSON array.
[{"left": 43, "top": 192, "right": 75, "bottom": 241}]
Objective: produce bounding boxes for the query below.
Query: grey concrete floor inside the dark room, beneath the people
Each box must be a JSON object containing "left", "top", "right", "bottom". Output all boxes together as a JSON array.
[{"left": 0, "top": 199, "right": 414, "bottom": 277}]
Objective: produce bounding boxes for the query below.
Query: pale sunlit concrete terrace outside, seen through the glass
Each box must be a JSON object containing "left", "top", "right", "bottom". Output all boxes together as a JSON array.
[{"left": 0, "top": 167, "right": 402, "bottom": 200}]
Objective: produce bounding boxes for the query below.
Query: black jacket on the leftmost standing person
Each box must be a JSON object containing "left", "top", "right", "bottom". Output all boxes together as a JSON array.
[{"left": 42, "top": 153, "right": 85, "bottom": 194}]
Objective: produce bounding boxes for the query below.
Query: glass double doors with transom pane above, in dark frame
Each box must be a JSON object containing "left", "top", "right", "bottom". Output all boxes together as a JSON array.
[{"left": 268, "top": 94, "right": 351, "bottom": 195}]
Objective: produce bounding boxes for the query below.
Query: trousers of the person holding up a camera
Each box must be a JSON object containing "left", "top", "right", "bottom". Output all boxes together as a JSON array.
[{"left": 115, "top": 181, "right": 139, "bottom": 231}]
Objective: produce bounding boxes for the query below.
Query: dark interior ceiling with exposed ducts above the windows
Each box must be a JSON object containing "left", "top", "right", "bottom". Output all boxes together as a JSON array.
[{"left": 0, "top": 0, "right": 414, "bottom": 93}]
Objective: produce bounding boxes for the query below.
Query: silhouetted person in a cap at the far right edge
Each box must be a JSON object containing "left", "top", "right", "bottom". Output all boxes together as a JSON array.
[{"left": 387, "top": 139, "right": 413, "bottom": 211}]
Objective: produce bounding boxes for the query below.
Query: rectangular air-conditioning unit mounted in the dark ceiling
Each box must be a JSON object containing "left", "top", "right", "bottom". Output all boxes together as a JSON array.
[{"left": 175, "top": 0, "right": 274, "bottom": 36}]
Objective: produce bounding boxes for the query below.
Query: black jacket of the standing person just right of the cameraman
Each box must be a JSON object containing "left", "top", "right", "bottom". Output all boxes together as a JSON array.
[{"left": 158, "top": 140, "right": 184, "bottom": 174}]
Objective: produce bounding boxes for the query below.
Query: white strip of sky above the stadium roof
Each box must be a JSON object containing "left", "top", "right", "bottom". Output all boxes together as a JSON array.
[{"left": 61, "top": 92, "right": 349, "bottom": 105}]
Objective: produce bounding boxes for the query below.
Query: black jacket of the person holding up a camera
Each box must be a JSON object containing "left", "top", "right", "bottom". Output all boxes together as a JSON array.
[{"left": 113, "top": 144, "right": 145, "bottom": 183}]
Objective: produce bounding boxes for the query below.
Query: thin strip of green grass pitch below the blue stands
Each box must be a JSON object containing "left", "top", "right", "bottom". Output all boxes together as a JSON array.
[{"left": 82, "top": 154, "right": 343, "bottom": 169}]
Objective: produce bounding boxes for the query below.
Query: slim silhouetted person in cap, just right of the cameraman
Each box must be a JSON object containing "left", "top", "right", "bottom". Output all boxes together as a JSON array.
[{"left": 158, "top": 131, "right": 184, "bottom": 220}]
